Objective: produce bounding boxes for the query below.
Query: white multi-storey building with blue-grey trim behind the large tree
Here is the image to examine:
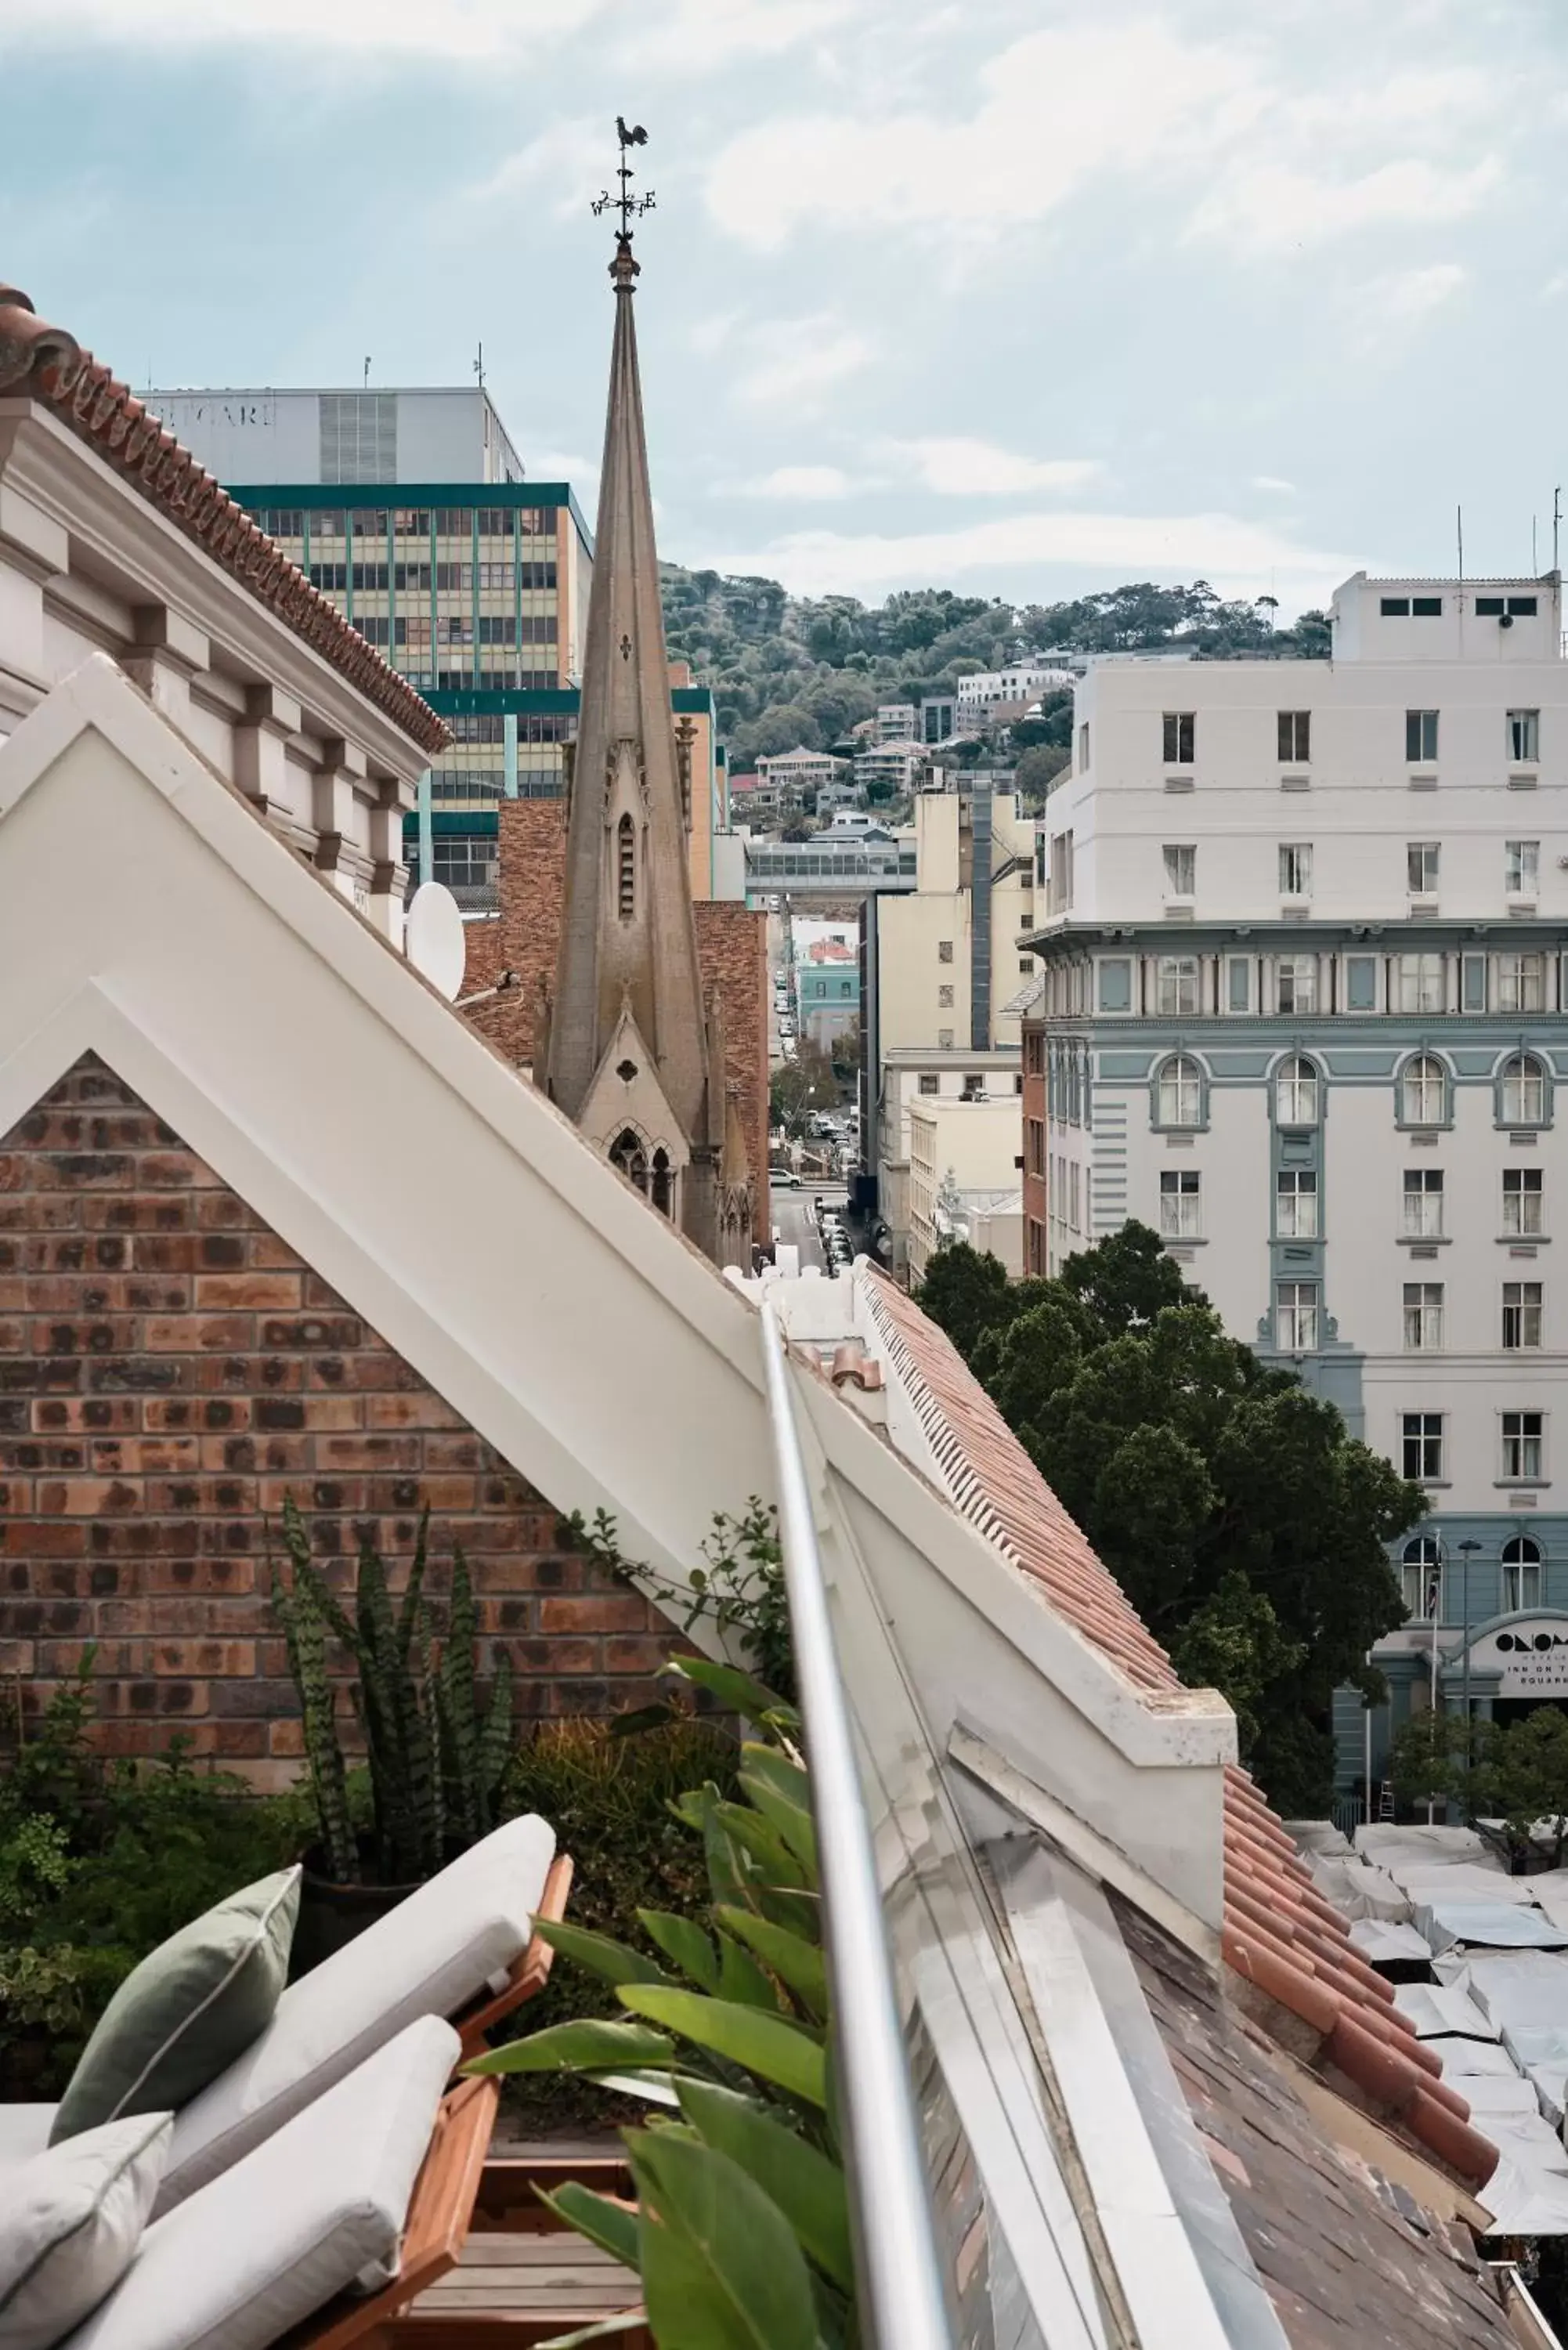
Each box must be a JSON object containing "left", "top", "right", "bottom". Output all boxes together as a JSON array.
[{"left": 1025, "top": 573, "right": 1568, "bottom": 1784}]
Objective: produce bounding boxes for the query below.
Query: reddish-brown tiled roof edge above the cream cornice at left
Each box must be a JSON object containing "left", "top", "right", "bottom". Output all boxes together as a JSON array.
[{"left": 0, "top": 282, "right": 449, "bottom": 752}]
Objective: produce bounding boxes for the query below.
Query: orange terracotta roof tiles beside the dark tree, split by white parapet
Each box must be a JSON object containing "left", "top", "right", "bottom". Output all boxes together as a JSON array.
[{"left": 865, "top": 1271, "right": 1498, "bottom": 2186}]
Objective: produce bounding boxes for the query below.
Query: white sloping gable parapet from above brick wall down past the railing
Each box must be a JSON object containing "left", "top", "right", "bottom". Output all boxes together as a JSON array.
[{"left": 0, "top": 656, "right": 1234, "bottom": 1925}]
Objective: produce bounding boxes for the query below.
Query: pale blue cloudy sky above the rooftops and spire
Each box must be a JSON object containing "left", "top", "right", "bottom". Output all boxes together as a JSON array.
[{"left": 0, "top": 0, "right": 1568, "bottom": 616}]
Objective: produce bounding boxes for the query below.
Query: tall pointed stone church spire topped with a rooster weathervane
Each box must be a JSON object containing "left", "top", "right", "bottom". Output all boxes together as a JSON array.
[{"left": 545, "top": 122, "right": 724, "bottom": 1253}]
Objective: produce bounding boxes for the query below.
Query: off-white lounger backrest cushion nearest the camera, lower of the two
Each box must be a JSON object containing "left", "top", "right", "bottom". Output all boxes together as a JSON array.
[{"left": 66, "top": 2016, "right": 458, "bottom": 2350}]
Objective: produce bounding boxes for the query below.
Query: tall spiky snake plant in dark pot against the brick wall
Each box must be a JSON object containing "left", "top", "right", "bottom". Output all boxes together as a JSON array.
[{"left": 273, "top": 1499, "right": 512, "bottom": 1976}]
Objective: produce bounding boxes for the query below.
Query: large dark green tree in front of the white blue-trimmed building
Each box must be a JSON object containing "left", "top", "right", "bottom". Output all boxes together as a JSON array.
[{"left": 922, "top": 1224, "right": 1427, "bottom": 1812}]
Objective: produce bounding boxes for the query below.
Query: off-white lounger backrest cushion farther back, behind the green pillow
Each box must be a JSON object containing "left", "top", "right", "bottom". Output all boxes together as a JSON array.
[{"left": 155, "top": 1814, "right": 555, "bottom": 2218}]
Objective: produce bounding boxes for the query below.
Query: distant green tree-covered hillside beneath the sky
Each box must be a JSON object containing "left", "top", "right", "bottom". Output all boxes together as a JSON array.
[{"left": 663, "top": 564, "right": 1328, "bottom": 780}]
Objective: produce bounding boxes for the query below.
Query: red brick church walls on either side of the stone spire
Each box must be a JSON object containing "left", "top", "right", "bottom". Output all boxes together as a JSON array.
[{"left": 465, "top": 799, "right": 768, "bottom": 1182}]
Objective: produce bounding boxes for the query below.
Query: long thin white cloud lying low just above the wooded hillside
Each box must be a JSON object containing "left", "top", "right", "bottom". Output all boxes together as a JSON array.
[{"left": 707, "top": 512, "right": 1357, "bottom": 599}]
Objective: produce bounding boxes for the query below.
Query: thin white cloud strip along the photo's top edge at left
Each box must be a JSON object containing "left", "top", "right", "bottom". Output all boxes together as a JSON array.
[{"left": 0, "top": 0, "right": 606, "bottom": 48}]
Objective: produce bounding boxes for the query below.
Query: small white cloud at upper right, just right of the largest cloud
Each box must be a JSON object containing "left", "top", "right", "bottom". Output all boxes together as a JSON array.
[{"left": 1190, "top": 160, "right": 1502, "bottom": 256}]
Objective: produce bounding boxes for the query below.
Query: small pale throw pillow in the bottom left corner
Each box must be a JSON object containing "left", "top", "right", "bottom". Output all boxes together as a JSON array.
[{"left": 0, "top": 2113, "right": 174, "bottom": 2350}]
